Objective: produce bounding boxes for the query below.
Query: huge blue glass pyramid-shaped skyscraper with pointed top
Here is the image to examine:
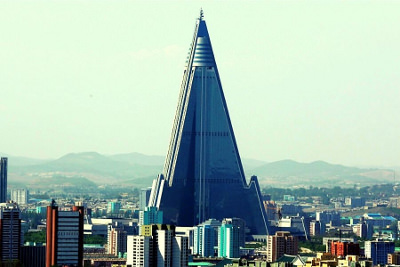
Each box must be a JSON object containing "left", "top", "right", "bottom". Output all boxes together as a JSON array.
[{"left": 149, "top": 12, "right": 268, "bottom": 237}]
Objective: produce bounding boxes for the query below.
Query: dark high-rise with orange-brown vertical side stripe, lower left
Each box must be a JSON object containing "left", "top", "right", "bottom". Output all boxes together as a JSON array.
[{"left": 46, "top": 201, "right": 84, "bottom": 267}]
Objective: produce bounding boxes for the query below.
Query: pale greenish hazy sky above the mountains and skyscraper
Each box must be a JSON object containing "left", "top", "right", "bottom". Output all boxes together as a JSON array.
[{"left": 0, "top": 0, "right": 400, "bottom": 166}]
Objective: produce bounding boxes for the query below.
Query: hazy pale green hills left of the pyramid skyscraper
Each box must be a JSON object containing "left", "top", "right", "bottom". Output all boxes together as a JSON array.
[{"left": 9, "top": 152, "right": 162, "bottom": 187}]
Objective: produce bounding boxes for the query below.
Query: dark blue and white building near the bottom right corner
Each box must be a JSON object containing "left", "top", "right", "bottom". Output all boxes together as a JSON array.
[{"left": 365, "top": 239, "right": 394, "bottom": 265}]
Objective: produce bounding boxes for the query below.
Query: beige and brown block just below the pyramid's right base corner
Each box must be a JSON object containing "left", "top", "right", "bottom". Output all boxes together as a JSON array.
[{"left": 267, "top": 231, "right": 298, "bottom": 262}]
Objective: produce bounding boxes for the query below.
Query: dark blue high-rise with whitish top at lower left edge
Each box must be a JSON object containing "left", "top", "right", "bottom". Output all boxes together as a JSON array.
[{"left": 0, "top": 202, "right": 21, "bottom": 266}]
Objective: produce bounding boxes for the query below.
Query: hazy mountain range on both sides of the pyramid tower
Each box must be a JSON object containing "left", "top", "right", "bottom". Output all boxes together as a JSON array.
[{"left": 2, "top": 152, "right": 394, "bottom": 188}]
